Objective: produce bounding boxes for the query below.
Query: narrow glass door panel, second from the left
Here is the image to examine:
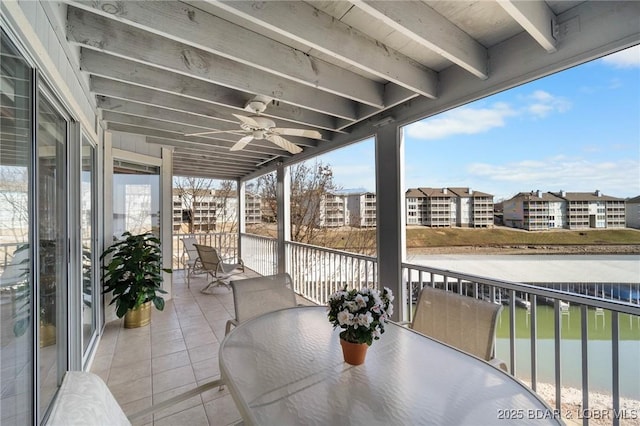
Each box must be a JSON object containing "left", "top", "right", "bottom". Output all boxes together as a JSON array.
[{"left": 36, "top": 95, "right": 68, "bottom": 413}]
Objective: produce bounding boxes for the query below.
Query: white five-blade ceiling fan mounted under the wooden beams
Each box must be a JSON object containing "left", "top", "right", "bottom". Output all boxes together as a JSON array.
[{"left": 185, "top": 98, "right": 322, "bottom": 154}]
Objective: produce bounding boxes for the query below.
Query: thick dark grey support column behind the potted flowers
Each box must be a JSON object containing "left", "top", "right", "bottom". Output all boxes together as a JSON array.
[{"left": 376, "top": 123, "right": 409, "bottom": 321}]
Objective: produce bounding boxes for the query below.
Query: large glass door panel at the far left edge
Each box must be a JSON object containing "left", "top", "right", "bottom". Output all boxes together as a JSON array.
[{"left": 0, "top": 29, "right": 34, "bottom": 425}]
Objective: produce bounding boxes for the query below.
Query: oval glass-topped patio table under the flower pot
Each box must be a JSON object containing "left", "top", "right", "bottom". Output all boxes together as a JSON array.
[{"left": 219, "top": 306, "right": 563, "bottom": 425}]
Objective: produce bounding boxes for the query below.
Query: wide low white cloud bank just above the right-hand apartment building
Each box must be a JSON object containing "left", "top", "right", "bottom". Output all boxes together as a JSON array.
[{"left": 467, "top": 156, "right": 640, "bottom": 197}]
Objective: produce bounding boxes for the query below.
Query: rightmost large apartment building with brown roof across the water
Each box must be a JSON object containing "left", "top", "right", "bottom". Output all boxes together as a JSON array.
[{"left": 504, "top": 191, "right": 625, "bottom": 231}]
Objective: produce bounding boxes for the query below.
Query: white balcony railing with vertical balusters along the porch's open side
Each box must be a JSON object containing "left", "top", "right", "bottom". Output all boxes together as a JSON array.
[{"left": 235, "top": 235, "right": 640, "bottom": 425}]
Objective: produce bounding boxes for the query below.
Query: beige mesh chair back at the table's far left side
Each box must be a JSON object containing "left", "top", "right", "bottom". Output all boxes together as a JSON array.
[{"left": 225, "top": 273, "right": 297, "bottom": 335}]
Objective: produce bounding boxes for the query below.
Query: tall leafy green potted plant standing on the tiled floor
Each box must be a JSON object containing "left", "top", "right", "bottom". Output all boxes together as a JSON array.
[{"left": 100, "top": 232, "right": 172, "bottom": 328}]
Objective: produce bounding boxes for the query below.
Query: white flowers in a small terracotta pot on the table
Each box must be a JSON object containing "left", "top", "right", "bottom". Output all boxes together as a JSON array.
[{"left": 328, "top": 287, "right": 393, "bottom": 365}]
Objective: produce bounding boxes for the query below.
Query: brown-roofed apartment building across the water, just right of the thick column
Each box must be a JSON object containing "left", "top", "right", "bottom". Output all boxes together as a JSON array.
[{"left": 405, "top": 187, "right": 493, "bottom": 228}]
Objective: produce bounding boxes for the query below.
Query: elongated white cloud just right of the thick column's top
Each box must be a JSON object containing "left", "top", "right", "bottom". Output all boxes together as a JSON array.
[{"left": 406, "top": 103, "right": 517, "bottom": 139}]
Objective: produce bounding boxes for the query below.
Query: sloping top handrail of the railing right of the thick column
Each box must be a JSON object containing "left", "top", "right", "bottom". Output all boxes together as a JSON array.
[{"left": 402, "top": 262, "right": 640, "bottom": 315}]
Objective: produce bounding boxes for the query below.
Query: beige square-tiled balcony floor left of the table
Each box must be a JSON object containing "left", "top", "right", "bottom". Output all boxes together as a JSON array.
[{"left": 91, "top": 270, "right": 257, "bottom": 426}]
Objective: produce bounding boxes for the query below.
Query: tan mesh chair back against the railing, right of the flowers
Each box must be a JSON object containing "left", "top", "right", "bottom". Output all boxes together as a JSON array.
[{"left": 411, "top": 287, "right": 507, "bottom": 371}]
